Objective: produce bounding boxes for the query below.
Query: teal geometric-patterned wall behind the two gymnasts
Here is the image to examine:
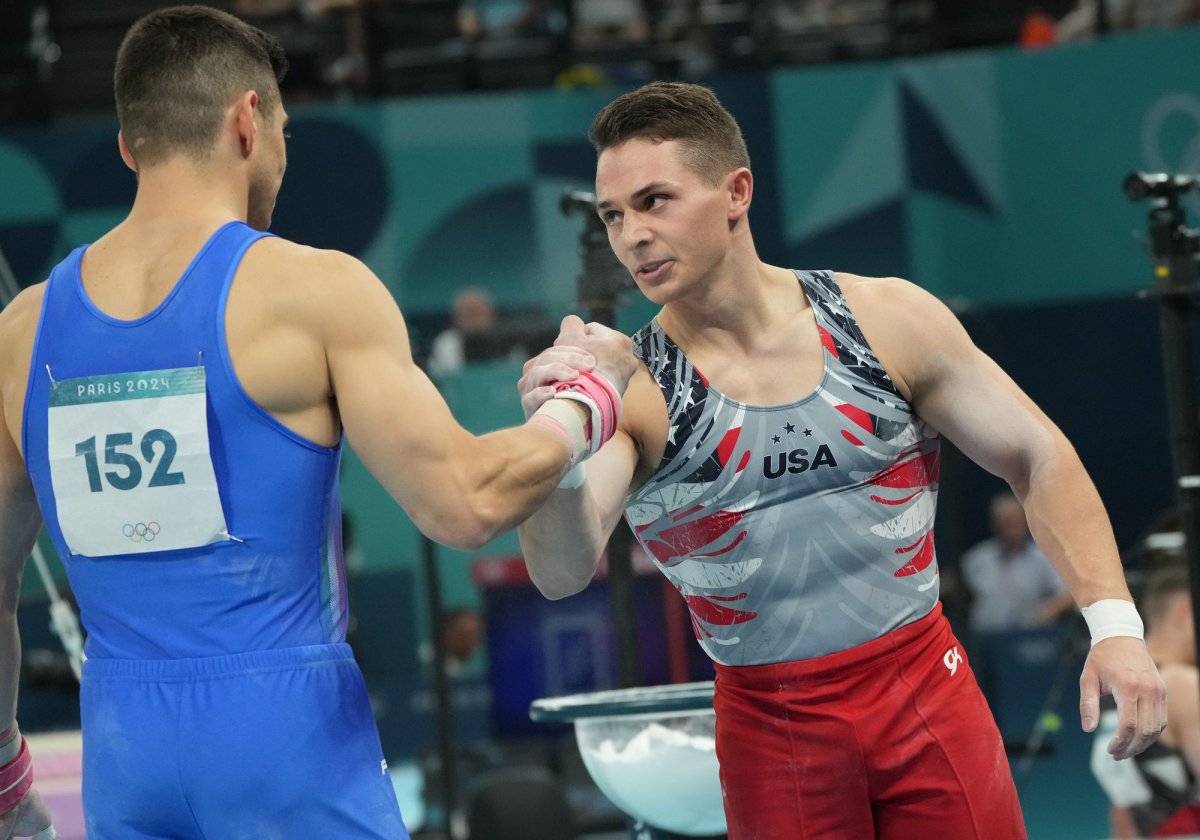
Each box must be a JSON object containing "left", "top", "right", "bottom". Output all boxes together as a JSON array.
[{"left": 9, "top": 28, "right": 1200, "bottom": 619}]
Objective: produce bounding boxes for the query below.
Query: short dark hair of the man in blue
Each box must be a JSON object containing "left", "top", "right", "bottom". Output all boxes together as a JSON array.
[{"left": 113, "top": 6, "right": 287, "bottom": 166}]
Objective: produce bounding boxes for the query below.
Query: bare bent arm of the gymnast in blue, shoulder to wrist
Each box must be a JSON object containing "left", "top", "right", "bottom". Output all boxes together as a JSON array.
[{"left": 313, "top": 258, "right": 614, "bottom": 548}]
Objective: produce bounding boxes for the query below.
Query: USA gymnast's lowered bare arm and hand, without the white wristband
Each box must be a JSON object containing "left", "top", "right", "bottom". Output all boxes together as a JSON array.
[{"left": 844, "top": 273, "right": 1166, "bottom": 758}]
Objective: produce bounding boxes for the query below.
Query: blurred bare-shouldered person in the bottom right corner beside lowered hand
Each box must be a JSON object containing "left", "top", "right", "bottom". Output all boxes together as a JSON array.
[{"left": 1091, "top": 565, "right": 1200, "bottom": 840}]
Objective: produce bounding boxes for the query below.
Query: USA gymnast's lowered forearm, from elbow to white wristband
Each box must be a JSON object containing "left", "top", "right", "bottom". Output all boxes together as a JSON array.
[{"left": 1013, "top": 439, "right": 1133, "bottom": 607}]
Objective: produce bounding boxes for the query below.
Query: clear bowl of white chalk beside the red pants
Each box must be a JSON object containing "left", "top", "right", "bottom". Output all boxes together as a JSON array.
[{"left": 529, "top": 682, "right": 725, "bottom": 840}]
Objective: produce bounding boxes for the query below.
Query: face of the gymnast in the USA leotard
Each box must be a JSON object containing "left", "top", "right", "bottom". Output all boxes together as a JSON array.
[{"left": 596, "top": 138, "right": 731, "bottom": 304}]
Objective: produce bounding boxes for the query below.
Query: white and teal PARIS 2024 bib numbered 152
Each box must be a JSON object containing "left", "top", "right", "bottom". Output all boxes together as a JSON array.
[{"left": 48, "top": 367, "right": 229, "bottom": 557}]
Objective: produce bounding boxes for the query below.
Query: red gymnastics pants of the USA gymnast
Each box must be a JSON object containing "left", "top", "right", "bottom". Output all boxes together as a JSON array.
[{"left": 714, "top": 606, "right": 1026, "bottom": 840}]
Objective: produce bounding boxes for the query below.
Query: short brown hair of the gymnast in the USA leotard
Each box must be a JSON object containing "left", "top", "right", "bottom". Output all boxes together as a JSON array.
[{"left": 588, "top": 82, "right": 750, "bottom": 184}]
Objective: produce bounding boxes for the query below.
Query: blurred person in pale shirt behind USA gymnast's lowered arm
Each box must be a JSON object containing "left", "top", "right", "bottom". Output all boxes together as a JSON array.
[{"left": 961, "top": 492, "right": 1074, "bottom": 635}]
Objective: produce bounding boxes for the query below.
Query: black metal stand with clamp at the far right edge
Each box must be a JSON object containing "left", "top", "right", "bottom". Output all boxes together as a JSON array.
[{"left": 1122, "top": 172, "right": 1200, "bottom": 667}]
